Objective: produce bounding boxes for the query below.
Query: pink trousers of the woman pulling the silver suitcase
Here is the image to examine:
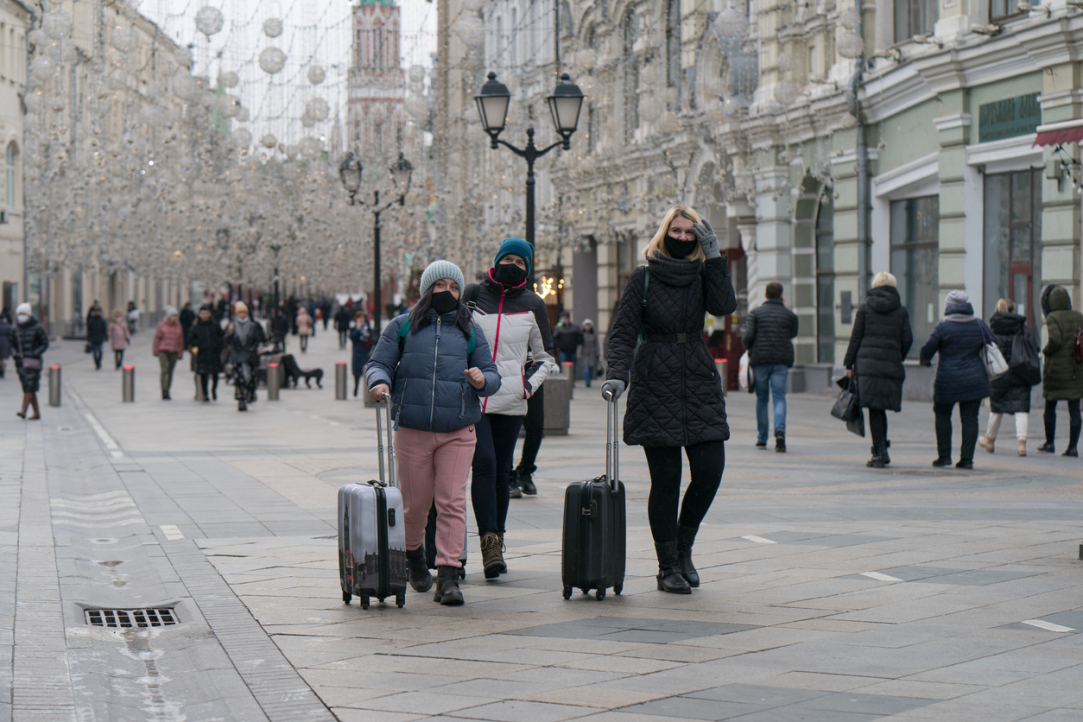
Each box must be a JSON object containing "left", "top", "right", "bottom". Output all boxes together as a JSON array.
[{"left": 395, "top": 424, "right": 477, "bottom": 567}]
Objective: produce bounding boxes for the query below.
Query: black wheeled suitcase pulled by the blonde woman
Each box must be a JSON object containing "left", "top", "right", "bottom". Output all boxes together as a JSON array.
[{"left": 560, "top": 389, "right": 625, "bottom": 600}]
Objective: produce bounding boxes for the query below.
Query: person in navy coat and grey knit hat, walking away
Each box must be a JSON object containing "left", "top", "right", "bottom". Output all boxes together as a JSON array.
[{"left": 921, "top": 290, "right": 992, "bottom": 469}]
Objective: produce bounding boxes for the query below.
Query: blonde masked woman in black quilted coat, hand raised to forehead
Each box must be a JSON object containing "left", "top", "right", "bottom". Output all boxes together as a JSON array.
[{"left": 602, "top": 206, "right": 738, "bottom": 594}]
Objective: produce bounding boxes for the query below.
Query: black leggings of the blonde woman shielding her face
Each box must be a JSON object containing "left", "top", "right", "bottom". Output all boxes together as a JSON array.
[{"left": 643, "top": 442, "right": 726, "bottom": 543}]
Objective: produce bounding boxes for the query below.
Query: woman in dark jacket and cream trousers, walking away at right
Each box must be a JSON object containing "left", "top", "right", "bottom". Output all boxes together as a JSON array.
[{"left": 978, "top": 299, "right": 1033, "bottom": 457}]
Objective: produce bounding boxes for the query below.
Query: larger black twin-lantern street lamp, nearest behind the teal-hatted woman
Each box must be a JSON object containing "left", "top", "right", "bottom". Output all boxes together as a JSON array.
[{"left": 474, "top": 73, "right": 584, "bottom": 270}]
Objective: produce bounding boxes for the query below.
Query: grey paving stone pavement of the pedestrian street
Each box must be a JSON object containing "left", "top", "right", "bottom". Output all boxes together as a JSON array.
[{"left": 6, "top": 332, "right": 1083, "bottom": 722}]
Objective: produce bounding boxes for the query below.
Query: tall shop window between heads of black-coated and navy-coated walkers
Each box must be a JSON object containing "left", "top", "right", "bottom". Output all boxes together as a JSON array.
[{"left": 891, "top": 196, "right": 940, "bottom": 357}]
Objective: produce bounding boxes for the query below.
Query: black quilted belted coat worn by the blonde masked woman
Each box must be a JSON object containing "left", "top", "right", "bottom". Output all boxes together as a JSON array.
[{"left": 605, "top": 257, "right": 738, "bottom": 446}]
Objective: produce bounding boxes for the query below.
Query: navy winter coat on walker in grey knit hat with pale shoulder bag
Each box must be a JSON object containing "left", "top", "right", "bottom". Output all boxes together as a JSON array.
[{"left": 921, "top": 303, "right": 990, "bottom": 404}]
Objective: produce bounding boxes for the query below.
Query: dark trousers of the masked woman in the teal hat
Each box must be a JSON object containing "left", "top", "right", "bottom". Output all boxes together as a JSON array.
[{"left": 470, "top": 413, "right": 523, "bottom": 535}]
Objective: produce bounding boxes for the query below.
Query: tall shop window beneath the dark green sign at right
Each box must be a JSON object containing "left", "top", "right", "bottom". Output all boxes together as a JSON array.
[{"left": 982, "top": 170, "right": 1042, "bottom": 329}]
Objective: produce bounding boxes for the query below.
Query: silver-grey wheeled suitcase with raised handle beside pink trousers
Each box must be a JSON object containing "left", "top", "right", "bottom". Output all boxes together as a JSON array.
[{"left": 338, "top": 394, "right": 407, "bottom": 609}]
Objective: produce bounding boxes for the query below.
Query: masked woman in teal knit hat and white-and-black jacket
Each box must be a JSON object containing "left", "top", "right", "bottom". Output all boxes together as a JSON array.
[{"left": 462, "top": 238, "right": 557, "bottom": 579}]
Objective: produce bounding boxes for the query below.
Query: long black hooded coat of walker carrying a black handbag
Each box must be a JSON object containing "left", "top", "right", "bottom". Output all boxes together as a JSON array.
[{"left": 843, "top": 286, "right": 914, "bottom": 411}]
